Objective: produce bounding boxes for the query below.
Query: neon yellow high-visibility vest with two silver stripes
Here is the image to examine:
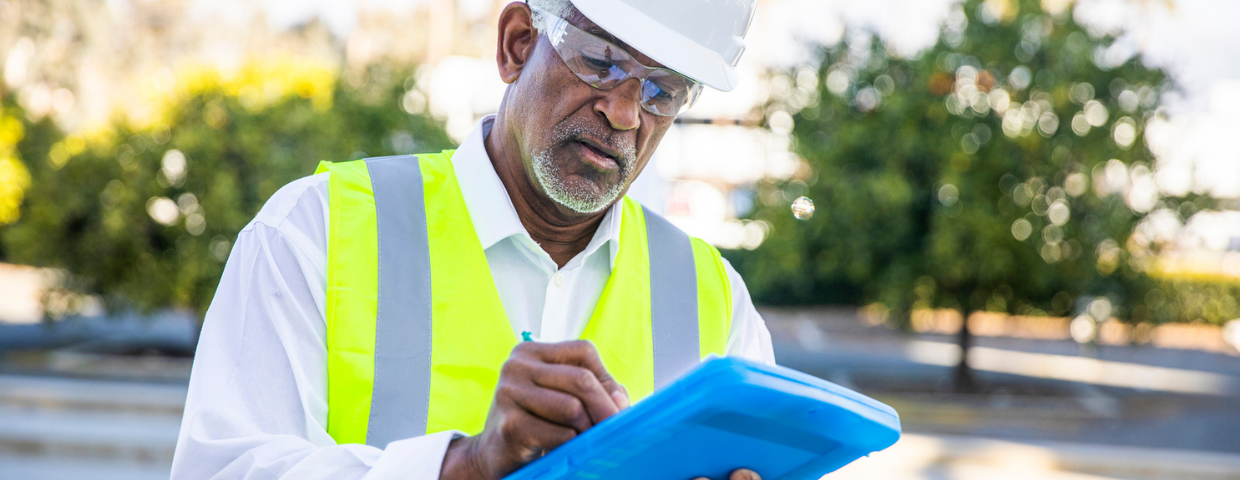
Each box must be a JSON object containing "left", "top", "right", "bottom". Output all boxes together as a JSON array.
[{"left": 317, "top": 150, "right": 732, "bottom": 448}]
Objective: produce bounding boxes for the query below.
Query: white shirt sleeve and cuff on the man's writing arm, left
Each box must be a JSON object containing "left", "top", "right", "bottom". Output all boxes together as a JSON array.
[{"left": 172, "top": 176, "right": 455, "bottom": 480}]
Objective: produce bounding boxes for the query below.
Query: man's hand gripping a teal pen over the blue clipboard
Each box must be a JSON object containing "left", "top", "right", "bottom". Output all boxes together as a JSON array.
[{"left": 439, "top": 340, "right": 629, "bottom": 480}]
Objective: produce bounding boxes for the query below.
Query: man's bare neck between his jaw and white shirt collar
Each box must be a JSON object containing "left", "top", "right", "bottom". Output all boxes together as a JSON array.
[{"left": 482, "top": 115, "right": 606, "bottom": 268}]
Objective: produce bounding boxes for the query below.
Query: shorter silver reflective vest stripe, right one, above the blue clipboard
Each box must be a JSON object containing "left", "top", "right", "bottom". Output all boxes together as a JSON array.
[{"left": 642, "top": 206, "right": 702, "bottom": 389}]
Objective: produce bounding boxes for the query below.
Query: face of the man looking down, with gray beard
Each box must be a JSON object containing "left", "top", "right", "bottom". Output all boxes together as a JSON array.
[{"left": 508, "top": 8, "right": 673, "bottom": 213}]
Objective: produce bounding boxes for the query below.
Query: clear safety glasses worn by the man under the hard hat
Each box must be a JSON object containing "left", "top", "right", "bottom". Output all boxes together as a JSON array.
[{"left": 531, "top": 7, "right": 702, "bottom": 117}]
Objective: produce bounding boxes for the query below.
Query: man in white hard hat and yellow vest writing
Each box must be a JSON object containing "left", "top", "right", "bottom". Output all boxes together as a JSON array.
[{"left": 172, "top": 0, "right": 774, "bottom": 480}]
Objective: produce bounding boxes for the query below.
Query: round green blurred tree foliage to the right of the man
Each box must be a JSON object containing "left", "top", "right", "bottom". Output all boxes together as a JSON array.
[{"left": 728, "top": 0, "right": 1213, "bottom": 325}]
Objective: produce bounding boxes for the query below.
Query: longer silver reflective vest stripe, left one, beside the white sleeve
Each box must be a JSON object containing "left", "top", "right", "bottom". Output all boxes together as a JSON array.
[{"left": 366, "top": 155, "right": 432, "bottom": 448}]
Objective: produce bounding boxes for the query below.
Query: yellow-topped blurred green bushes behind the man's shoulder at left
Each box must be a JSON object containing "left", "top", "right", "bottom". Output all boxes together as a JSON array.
[{"left": 0, "top": 60, "right": 450, "bottom": 315}]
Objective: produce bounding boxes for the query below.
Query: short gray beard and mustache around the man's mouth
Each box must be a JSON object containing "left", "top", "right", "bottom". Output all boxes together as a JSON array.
[{"left": 531, "top": 120, "right": 637, "bottom": 213}]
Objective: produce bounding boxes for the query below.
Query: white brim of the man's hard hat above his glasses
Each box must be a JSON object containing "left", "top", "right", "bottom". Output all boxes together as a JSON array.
[{"left": 573, "top": 0, "right": 739, "bottom": 92}]
